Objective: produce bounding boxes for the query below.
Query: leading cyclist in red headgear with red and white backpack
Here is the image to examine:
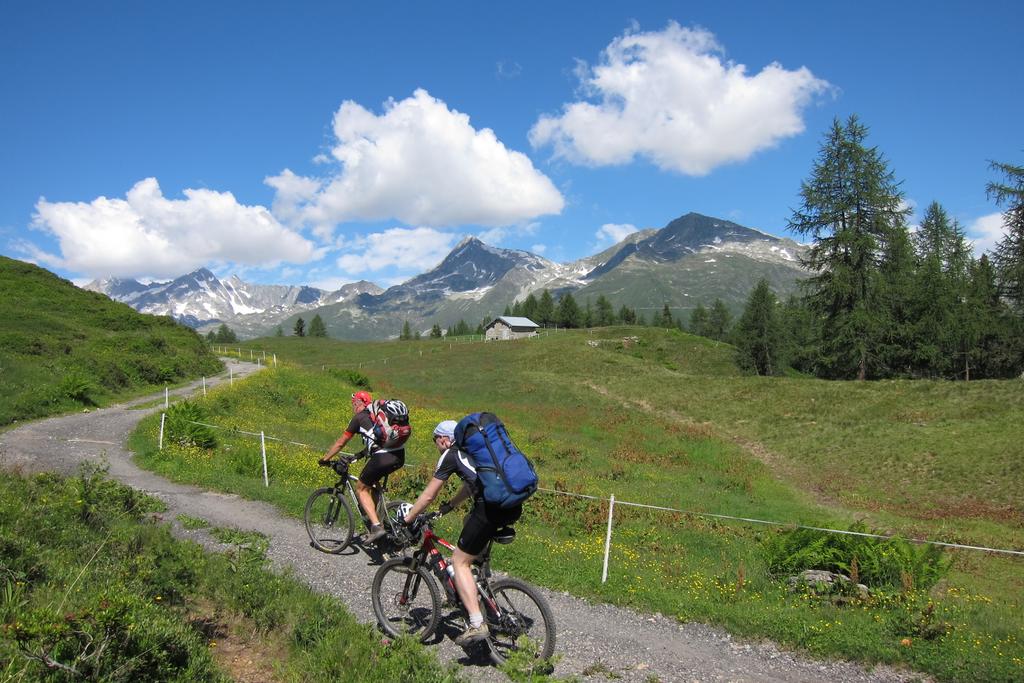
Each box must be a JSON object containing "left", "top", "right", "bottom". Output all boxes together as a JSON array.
[{"left": 319, "top": 391, "right": 412, "bottom": 543}]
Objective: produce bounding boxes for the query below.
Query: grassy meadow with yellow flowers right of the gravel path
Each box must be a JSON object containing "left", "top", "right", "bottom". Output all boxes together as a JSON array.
[{"left": 134, "top": 328, "right": 1024, "bottom": 680}]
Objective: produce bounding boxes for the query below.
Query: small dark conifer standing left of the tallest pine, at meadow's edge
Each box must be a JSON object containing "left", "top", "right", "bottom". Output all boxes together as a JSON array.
[{"left": 734, "top": 280, "right": 787, "bottom": 375}]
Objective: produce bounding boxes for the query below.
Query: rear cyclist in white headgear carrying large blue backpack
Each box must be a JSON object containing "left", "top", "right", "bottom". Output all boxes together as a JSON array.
[{"left": 403, "top": 413, "right": 537, "bottom": 645}]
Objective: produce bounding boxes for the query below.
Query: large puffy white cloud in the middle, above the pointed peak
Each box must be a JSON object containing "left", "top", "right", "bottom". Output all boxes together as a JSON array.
[{"left": 266, "top": 89, "right": 564, "bottom": 234}]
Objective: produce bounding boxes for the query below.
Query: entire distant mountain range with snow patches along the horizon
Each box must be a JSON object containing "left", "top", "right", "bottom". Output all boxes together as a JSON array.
[{"left": 85, "top": 213, "right": 808, "bottom": 339}]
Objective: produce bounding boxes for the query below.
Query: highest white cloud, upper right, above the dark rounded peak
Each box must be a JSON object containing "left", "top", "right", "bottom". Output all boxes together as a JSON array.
[{"left": 529, "top": 22, "right": 830, "bottom": 175}]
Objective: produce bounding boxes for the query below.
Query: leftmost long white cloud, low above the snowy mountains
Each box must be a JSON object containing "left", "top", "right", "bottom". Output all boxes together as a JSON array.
[{"left": 33, "top": 178, "right": 316, "bottom": 279}]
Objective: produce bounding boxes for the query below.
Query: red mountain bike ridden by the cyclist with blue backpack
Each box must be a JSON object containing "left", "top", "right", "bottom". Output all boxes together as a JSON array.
[{"left": 370, "top": 512, "right": 555, "bottom": 665}]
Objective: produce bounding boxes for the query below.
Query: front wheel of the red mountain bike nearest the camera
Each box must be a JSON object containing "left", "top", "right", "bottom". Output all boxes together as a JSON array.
[{"left": 370, "top": 557, "right": 441, "bottom": 642}]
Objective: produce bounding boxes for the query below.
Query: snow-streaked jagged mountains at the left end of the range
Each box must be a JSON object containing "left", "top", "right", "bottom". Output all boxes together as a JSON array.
[{"left": 85, "top": 268, "right": 383, "bottom": 334}]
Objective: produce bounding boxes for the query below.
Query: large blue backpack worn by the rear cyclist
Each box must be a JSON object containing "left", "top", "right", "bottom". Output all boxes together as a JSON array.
[{"left": 455, "top": 413, "right": 537, "bottom": 508}]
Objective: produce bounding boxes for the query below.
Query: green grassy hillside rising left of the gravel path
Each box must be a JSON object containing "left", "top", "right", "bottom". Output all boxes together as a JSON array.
[{"left": 0, "top": 256, "right": 223, "bottom": 426}]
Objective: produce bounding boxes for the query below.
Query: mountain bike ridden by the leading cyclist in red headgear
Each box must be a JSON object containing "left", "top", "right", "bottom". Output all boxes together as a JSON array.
[{"left": 302, "top": 453, "right": 404, "bottom": 555}]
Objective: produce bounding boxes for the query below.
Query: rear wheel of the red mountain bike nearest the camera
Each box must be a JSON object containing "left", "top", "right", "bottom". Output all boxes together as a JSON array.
[{"left": 483, "top": 579, "right": 555, "bottom": 665}]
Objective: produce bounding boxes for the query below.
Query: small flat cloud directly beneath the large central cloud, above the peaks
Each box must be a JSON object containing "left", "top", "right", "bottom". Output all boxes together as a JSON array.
[{"left": 337, "top": 227, "right": 459, "bottom": 282}]
